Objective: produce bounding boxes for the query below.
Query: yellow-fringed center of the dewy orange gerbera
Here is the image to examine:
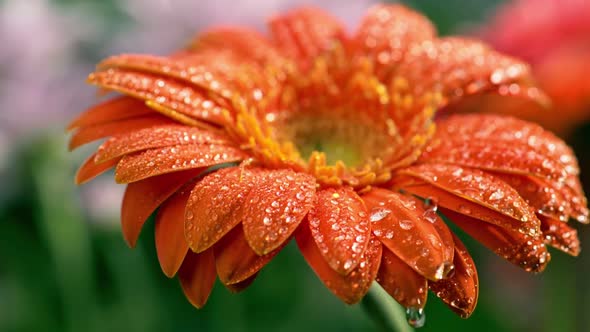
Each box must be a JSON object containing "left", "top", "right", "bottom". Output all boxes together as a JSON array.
[{"left": 229, "top": 47, "right": 440, "bottom": 190}]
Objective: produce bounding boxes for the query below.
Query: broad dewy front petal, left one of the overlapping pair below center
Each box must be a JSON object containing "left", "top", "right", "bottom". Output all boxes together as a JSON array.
[{"left": 184, "top": 167, "right": 259, "bottom": 253}]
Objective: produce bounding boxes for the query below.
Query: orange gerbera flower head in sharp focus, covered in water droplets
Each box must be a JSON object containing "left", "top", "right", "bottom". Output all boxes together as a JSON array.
[{"left": 70, "top": 6, "right": 588, "bottom": 324}]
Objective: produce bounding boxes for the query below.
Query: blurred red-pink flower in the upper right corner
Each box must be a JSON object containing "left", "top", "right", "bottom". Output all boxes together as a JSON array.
[{"left": 483, "top": 0, "right": 590, "bottom": 135}]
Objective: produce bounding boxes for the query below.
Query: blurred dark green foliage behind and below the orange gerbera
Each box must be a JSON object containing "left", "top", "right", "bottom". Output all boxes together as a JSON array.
[{"left": 0, "top": 0, "right": 590, "bottom": 332}]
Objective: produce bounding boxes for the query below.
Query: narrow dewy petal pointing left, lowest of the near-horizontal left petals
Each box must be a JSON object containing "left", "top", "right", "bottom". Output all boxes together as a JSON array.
[{"left": 115, "top": 144, "right": 247, "bottom": 183}]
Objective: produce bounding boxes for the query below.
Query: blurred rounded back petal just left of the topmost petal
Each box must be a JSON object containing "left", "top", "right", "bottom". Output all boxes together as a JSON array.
[{"left": 269, "top": 8, "right": 344, "bottom": 61}]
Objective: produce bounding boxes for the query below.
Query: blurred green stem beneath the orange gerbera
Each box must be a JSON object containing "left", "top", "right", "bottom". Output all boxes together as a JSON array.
[{"left": 361, "top": 283, "right": 413, "bottom": 332}]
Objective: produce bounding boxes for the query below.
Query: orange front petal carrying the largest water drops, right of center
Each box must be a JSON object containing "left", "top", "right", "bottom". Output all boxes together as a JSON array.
[{"left": 363, "top": 188, "right": 453, "bottom": 280}]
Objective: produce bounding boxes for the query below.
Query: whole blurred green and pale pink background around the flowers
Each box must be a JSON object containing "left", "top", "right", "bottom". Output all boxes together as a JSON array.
[{"left": 0, "top": 0, "right": 590, "bottom": 331}]
